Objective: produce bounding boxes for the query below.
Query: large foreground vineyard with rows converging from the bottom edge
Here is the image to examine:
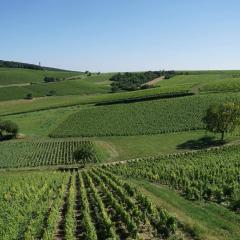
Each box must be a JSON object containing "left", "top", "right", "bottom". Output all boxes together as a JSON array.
[{"left": 0, "top": 169, "right": 177, "bottom": 240}]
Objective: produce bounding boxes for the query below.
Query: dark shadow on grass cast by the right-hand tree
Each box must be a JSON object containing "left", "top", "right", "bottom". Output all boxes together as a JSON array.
[{"left": 177, "top": 136, "right": 225, "bottom": 150}]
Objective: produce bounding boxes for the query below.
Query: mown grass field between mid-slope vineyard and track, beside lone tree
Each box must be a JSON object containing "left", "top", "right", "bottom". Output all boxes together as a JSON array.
[{"left": 100, "top": 131, "right": 225, "bottom": 161}]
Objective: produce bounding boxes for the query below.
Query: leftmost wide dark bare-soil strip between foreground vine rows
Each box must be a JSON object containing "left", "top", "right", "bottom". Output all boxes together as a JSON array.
[{"left": 55, "top": 176, "right": 72, "bottom": 240}]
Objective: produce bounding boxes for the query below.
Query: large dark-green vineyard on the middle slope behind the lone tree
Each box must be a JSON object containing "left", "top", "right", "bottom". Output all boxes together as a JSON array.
[{"left": 50, "top": 94, "right": 240, "bottom": 137}]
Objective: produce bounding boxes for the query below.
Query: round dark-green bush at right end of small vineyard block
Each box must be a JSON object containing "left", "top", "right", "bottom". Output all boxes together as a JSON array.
[{"left": 73, "top": 144, "right": 96, "bottom": 163}]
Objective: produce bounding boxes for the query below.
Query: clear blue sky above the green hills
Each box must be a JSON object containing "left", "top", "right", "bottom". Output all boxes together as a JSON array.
[{"left": 0, "top": 0, "right": 240, "bottom": 71}]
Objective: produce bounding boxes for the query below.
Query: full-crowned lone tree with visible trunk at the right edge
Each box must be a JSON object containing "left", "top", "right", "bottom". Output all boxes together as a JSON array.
[{"left": 203, "top": 102, "right": 240, "bottom": 142}]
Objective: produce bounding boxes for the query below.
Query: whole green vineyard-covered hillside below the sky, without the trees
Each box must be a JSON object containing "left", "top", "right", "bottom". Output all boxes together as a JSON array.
[{"left": 0, "top": 65, "right": 240, "bottom": 240}]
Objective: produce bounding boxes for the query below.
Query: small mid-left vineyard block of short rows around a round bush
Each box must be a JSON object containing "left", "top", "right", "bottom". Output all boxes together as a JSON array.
[{"left": 0, "top": 139, "right": 105, "bottom": 168}]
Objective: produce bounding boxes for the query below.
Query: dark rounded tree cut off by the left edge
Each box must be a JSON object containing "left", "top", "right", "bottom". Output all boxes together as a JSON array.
[{"left": 0, "top": 120, "right": 19, "bottom": 138}]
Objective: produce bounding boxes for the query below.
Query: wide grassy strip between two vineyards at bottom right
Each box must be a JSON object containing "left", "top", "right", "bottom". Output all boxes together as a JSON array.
[{"left": 129, "top": 178, "right": 240, "bottom": 240}]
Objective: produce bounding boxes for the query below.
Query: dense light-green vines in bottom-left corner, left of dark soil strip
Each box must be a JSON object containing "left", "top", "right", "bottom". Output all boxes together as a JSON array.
[{"left": 0, "top": 172, "right": 68, "bottom": 239}]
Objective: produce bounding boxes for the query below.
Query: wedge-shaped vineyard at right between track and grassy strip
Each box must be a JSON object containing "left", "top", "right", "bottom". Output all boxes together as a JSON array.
[{"left": 107, "top": 145, "right": 240, "bottom": 211}]
